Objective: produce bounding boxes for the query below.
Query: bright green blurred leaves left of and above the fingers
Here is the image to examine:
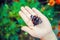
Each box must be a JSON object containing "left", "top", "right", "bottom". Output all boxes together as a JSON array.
[{"left": 0, "top": 0, "right": 57, "bottom": 40}]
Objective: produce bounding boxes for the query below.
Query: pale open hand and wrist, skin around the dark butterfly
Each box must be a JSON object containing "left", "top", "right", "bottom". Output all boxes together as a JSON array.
[{"left": 19, "top": 6, "right": 57, "bottom": 40}]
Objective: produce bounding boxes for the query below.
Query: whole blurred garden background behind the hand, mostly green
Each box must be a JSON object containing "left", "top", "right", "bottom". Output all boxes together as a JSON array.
[{"left": 0, "top": 0, "right": 60, "bottom": 40}]
